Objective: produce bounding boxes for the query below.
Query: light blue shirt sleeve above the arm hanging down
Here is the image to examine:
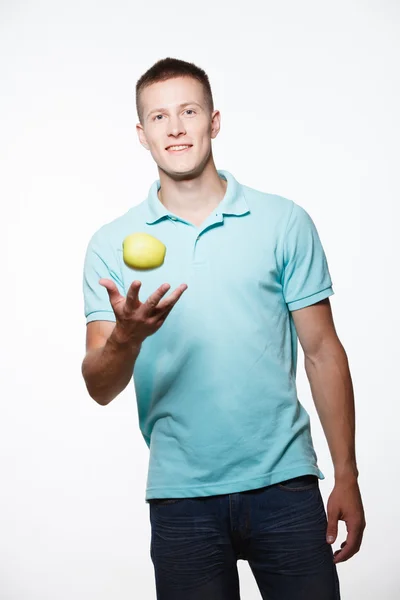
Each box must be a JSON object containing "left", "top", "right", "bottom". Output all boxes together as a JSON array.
[{"left": 282, "top": 203, "right": 334, "bottom": 311}]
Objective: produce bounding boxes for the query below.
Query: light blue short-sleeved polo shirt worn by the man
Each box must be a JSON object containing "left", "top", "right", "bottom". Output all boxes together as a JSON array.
[{"left": 83, "top": 170, "right": 334, "bottom": 500}]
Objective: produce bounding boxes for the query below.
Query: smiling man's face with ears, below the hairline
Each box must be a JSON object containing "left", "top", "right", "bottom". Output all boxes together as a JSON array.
[{"left": 136, "top": 77, "right": 220, "bottom": 180}]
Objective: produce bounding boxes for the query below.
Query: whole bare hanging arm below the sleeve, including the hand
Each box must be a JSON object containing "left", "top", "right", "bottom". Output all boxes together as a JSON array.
[{"left": 291, "top": 298, "right": 366, "bottom": 563}]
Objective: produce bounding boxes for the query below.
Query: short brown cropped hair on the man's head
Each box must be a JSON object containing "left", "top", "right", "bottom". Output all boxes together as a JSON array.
[{"left": 136, "top": 57, "right": 214, "bottom": 123}]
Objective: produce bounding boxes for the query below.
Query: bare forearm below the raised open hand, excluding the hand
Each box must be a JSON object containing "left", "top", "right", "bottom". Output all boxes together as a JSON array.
[{"left": 82, "top": 328, "right": 140, "bottom": 405}]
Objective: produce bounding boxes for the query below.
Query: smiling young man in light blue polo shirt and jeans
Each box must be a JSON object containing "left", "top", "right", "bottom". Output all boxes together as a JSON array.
[{"left": 82, "top": 58, "right": 365, "bottom": 600}]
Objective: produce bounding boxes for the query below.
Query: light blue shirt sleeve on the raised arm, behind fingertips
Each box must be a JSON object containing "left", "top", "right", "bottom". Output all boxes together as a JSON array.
[{"left": 83, "top": 232, "right": 125, "bottom": 323}]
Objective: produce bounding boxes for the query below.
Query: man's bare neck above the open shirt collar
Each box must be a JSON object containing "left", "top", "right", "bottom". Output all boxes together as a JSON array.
[{"left": 158, "top": 161, "right": 227, "bottom": 225}]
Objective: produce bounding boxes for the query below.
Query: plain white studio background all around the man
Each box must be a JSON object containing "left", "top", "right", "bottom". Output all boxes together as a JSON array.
[{"left": 0, "top": 0, "right": 400, "bottom": 600}]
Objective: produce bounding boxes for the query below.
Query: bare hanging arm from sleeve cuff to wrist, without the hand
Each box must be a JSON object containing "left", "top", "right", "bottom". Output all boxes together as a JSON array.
[{"left": 291, "top": 298, "right": 358, "bottom": 479}]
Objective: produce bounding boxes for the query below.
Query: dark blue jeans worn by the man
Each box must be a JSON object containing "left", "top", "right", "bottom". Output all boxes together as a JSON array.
[{"left": 149, "top": 475, "right": 340, "bottom": 600}]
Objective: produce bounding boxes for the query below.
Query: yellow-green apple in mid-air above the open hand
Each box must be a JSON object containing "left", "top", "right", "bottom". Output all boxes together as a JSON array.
[{"left": 122, "top": 233, "right": 167, "bottom": 269}]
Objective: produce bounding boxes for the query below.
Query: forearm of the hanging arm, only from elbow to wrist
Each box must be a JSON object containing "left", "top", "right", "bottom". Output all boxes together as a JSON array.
[{"left": 305, "top": 340, "right": 358, "bottom": 479}]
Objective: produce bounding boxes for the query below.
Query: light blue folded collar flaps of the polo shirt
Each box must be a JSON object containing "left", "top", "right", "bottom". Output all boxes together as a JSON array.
[{"left": 146, "top": 170, "right": 250, "bottom": 225}]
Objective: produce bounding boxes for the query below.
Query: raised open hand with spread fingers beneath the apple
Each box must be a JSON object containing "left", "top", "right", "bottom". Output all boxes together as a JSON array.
[{"left": 99, "top": 279, "right": 188, "bottom": 346}]
